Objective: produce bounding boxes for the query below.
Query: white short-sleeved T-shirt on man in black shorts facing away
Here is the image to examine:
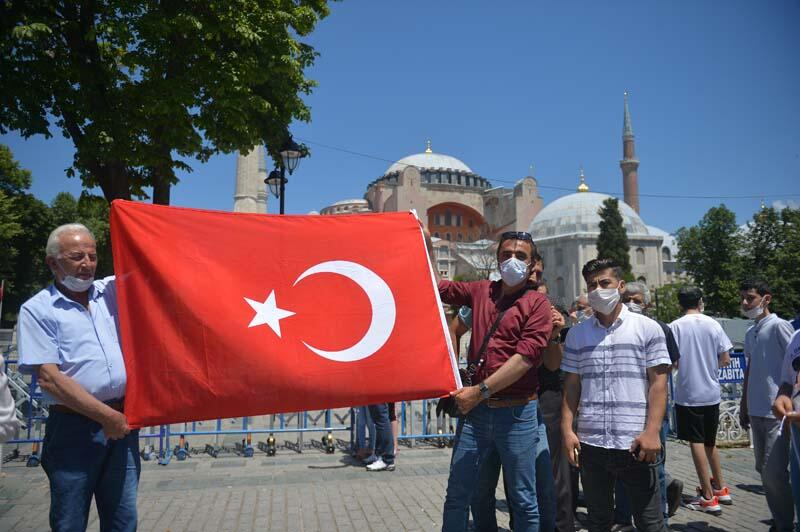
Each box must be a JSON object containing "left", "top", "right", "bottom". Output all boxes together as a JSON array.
[{"left": 669, "top": 314, "right": 733, "bottom": 406}]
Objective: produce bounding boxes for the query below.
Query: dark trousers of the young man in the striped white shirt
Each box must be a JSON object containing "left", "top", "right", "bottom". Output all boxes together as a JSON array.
[{"left": 580, "top": 443, "right": 667, "bottom": 532}]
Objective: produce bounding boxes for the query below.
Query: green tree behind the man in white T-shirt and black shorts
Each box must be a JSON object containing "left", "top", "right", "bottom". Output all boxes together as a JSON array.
[{"left": 677, "top": 205, "right": 742, "bottom": 317}]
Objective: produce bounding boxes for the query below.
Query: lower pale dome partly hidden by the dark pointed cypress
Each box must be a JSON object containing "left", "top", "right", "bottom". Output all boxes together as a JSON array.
[{"left": 529, "top": 192, "right": 649, "bottom": 240}]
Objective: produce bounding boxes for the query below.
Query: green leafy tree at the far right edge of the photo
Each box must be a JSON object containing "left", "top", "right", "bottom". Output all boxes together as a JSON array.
[{"left": 743, "top": 208, "right": 800, "bottom": 318}]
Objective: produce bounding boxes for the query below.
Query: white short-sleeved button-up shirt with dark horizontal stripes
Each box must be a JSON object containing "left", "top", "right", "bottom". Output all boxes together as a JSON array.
[{"left": 561, "top": 306, "right": 670, "bottom": 450}]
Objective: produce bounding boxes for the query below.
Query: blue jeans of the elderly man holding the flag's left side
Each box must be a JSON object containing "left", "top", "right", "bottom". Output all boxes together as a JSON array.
[{"left": 42, "top": 411, "right": 142, "bottom": 532}]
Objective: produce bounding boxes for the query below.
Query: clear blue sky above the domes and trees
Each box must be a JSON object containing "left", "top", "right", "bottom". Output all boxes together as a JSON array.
[{"left": 0, "top": 0, "right": 800, "bottom": 231}]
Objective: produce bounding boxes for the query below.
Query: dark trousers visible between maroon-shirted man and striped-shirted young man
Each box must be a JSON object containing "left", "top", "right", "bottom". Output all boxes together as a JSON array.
[{"left": 539, "top": 390, "right": 575, "bottom": 532}]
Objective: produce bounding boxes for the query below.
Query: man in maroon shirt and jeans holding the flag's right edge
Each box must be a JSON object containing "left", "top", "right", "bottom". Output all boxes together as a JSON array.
[{"left": 428, "top": 232, "right": 552, "bottom": 532}]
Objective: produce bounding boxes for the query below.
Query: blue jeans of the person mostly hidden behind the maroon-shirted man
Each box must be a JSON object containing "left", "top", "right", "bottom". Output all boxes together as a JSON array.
[{"left": 470, "top": 412, "right": 556, "bottom": 532}]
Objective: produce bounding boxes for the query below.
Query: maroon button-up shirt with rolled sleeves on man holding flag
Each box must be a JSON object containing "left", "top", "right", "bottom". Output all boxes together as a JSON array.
[{"left": 439, "top": 280, "right": 553, "bottom": 398}]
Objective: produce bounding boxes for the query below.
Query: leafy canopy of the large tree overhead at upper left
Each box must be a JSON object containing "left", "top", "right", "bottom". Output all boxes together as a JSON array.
[{"left": 0, "top": 0, "right": 328, "bottom": 204}]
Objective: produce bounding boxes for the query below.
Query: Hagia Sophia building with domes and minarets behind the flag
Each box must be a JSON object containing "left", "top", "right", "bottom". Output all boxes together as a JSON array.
[{"left": 234, "top": 93, "right": 677, "bottom": 305}]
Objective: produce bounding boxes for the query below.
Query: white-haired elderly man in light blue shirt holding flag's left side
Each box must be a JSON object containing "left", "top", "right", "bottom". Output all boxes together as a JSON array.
[{"left": 19, "top": 224, "right": 141, "bottom": 532}]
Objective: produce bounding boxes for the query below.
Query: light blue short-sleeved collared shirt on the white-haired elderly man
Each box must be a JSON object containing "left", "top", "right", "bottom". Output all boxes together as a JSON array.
[{"left": 18, "top": 277, "right": 127, "bottom": 404}]
